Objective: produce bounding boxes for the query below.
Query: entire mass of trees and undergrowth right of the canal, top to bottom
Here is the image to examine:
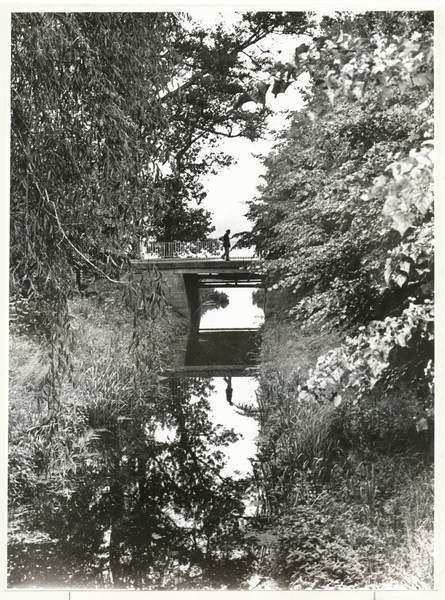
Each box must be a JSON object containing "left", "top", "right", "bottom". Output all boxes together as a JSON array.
[{"left": 243, "top": 9, "right": 434, "bottom": 589}]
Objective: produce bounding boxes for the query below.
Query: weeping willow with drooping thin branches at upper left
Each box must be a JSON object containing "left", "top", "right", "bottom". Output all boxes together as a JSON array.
[{"left": 10, "top": 13, "right": 178, "bottom": 322}]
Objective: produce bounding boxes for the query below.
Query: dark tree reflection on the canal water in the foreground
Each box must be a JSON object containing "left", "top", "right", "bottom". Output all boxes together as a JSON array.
[{"left": 10, "top": 369, "right": 255, "bottom": 589}]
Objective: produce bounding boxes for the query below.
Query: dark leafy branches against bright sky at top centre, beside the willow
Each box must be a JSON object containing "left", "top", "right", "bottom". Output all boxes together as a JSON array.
[{"left": 160, "top": 12, "right": 310, "bottom": 164}]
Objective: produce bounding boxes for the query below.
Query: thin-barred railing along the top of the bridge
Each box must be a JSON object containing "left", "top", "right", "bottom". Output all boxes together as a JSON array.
[{"left": 141, "top": 239, "right": 254, "bottom": 260}]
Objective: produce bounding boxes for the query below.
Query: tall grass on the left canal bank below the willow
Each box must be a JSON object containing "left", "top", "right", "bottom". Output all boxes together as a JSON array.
[{"left": 8, "top": 284, "right": 182, "bottom": 514}]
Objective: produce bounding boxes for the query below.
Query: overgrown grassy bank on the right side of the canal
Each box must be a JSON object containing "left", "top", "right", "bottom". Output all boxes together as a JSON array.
[{"left": 250, "top": 322, "right": 434, "bottom": 590}]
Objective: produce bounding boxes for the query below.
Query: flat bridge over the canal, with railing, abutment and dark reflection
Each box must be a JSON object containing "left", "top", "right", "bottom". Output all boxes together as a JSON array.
[{"left": 132, "top": 240, "right": 263, "bottom": 377}]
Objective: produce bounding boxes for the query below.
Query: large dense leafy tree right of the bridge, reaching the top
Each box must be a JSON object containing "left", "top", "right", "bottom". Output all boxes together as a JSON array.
[{"left": 245, "top": 9, "right": 433, "bottom": 326}]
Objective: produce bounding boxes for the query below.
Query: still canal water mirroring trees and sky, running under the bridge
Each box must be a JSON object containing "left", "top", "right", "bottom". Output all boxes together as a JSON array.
[{"left": 8, "top": 288, "right": 263, "bottom": 590}]
